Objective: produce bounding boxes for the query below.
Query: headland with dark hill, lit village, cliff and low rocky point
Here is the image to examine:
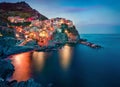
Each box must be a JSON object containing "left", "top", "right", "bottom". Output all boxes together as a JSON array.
[{"left": 0, "top": 1, "right": 100, "bottom": 48}]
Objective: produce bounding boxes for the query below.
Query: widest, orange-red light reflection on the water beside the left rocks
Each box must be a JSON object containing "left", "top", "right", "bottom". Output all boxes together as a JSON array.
[{"left": 11, "top": 52, "right": 31, "bottom": 81}]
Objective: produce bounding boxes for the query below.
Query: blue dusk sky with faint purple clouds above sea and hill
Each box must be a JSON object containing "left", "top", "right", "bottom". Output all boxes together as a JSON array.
[{"left": 0, "top": 0, "right": 120, "bottom": 34}]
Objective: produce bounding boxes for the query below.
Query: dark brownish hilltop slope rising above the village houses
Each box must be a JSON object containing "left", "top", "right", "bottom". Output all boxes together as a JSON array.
[{"left": 0, "top": 2, "right": 48, "bottom": 22}]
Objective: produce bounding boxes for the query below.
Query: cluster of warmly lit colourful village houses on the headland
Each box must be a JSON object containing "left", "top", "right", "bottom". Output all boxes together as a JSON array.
[{"left": 8, "top": 16, "right": 78, "bottom": 46}]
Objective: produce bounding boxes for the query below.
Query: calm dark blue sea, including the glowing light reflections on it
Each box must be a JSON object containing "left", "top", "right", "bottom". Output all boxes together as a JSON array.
[{"left": 11, "top": 34, "right": 120, "bottom": 87}]
